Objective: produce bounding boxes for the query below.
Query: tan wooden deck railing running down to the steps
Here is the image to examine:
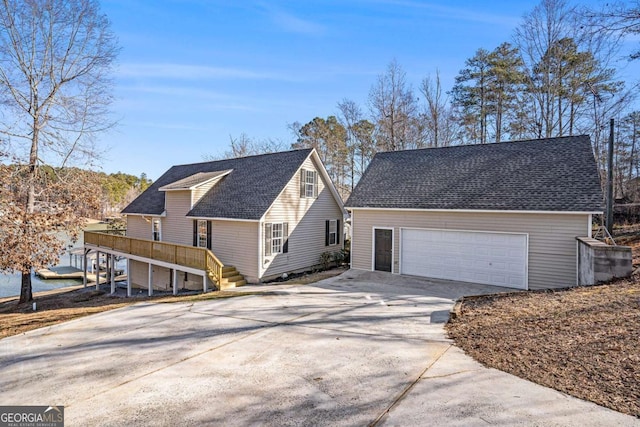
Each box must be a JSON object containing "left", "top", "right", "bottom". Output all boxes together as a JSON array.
[{"left": 84, "top": 231, "right": 224, "bottom": 283}]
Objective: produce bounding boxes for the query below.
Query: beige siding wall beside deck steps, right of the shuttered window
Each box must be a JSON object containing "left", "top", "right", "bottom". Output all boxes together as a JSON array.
[{"left": 211, "top": 220, "right": 258, "bottom": 282}]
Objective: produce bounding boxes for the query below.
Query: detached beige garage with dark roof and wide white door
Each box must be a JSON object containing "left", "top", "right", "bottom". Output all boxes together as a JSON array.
[{"left": 346, "top": 135, "right": 603, "bottom": 289}]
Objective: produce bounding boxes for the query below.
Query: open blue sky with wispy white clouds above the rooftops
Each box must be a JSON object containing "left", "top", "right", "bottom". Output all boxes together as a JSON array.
[{"left": 99, "top": 0, "right": 636, "bottom": 179}]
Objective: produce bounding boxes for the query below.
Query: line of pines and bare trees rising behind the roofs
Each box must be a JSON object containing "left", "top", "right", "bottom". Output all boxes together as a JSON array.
[{"left": 225, "top": 0, "right": 640, "bottom": 202}]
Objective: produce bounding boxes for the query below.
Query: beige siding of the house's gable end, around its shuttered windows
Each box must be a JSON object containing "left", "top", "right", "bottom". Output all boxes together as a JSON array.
[{"left": 261, "top": 158, "right": 344, "bottom": 278}]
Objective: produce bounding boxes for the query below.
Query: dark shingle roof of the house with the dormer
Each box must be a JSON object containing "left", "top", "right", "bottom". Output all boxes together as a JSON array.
[{"left": 122, "top": 149, "right": 312, "bottom": 220}]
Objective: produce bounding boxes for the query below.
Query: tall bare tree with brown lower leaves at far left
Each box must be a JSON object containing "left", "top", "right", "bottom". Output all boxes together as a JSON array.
[{"left": 0, "top": 0, "right": 118, "bottom": 302}]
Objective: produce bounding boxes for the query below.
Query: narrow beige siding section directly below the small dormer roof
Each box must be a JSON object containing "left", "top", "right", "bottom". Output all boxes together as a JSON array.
[{"left": 162, "top": 190, "right": 193, "bottom": 246}]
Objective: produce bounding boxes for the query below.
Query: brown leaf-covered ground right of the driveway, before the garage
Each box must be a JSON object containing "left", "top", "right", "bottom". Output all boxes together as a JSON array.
[{"left": 447, "top": 231, "right": 640, "bottom": 417}]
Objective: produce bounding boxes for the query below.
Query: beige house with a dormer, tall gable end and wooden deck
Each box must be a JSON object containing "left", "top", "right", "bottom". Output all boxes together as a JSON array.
[{"left": 112, "top": 149, "right": 346, "bottom": 291}]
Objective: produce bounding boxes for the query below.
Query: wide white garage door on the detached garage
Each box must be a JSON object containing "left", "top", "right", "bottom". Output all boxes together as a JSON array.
[{"left": 400, "top": 229, "right": 527, "bottom": 289}]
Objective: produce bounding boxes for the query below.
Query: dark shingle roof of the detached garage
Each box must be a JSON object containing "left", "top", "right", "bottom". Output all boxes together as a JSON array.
[{"left": 346, "top": 135, "right": 603, "bottom": 213}]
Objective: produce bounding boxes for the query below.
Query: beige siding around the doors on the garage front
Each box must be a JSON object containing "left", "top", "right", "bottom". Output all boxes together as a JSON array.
[{"left": 351, "top": 209, "right": 589, "bottom": 289}]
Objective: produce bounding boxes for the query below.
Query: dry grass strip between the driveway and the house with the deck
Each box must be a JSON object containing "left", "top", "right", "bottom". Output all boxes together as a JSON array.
[{"left": 0, "top": 269, "right": 344, "bottom": 339}]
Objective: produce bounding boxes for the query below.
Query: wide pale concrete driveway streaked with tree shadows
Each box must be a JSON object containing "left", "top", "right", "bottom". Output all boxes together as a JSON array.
[{"left": 0, "top": 271, "right": 640, "bottom": 426}]
